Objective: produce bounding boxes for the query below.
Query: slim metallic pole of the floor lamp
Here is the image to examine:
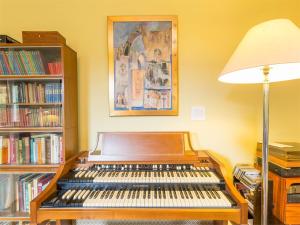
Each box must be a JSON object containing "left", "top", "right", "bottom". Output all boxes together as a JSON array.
[{"left": 261, "top": 66, "right": 270, "bottom": 225}]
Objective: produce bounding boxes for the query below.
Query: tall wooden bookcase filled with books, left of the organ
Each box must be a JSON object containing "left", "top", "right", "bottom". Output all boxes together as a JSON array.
[{"left": 0, "top": 39, "right": 78, "bottom": 224}]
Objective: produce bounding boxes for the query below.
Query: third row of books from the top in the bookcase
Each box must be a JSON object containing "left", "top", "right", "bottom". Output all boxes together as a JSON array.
[{"left": 0, "top": 105, "right": 62, "bottom": 127}]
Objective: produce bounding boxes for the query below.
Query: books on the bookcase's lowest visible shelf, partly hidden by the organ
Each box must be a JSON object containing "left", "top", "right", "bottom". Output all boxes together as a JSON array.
[{"left": 15, "top": 174, "right": 53, "bottom": 212}]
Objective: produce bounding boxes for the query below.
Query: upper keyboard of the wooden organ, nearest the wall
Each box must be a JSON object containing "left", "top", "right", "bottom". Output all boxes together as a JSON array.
[{"left": 60, "top": 164, "right": 222, "bottom": 184}]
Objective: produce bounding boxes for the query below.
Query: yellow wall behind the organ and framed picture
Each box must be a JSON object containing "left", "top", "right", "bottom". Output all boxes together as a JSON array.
[{"left": 0, "top": 0, "right": 300, "bottom": 168}]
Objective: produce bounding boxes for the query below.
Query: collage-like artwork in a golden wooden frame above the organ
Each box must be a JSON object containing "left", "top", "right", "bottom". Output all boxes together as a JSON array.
[{"left": 108, "top": 16, "right": 178, "bottom": 116}]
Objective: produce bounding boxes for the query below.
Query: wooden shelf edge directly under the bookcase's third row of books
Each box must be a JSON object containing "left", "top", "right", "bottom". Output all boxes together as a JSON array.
[{"left": 0, "top": 127, "right": 63, "bottom": 133}]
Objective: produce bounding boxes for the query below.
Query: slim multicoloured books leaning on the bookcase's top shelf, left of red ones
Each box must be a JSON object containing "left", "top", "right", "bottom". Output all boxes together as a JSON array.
[{"left": 0, "top": 50, "right": 45, "bottom": 75}]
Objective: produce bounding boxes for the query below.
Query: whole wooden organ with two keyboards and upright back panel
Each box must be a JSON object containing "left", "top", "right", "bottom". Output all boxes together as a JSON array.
[{"left": 30, "top": 132, "right": 248, "bottom": 224}]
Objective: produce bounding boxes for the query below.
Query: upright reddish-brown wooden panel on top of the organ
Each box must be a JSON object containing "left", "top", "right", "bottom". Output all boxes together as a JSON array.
[{"left": 101, "top": 132, "right": 186, "bottom": 156}]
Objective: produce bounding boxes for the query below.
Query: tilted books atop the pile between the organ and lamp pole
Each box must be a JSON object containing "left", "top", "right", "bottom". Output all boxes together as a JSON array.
[{"left": 233, "top": 164, "right": 261, "bottom": 190}]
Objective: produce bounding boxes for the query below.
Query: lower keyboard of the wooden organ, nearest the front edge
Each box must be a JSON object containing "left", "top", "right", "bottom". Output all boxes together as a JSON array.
[{"left": 42, "top": 185, "right": 235, "bottom": 208}]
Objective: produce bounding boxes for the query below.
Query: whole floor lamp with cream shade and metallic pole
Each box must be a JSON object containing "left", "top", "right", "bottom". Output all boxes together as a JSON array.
[{"left": 219, "top": 19, "right": 300, "bottom": 225}]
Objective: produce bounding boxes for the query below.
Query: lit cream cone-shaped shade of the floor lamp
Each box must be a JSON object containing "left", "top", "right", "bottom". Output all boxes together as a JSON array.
[{"left": 219, "top": 19, "right": 300, "bottom": 83}]
